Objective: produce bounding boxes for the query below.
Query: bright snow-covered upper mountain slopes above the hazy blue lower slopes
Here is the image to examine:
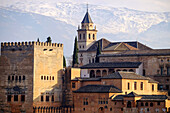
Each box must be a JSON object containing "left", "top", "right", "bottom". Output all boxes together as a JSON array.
[{"left": 1, "top": 0, "right": 170, "bottom": 33}]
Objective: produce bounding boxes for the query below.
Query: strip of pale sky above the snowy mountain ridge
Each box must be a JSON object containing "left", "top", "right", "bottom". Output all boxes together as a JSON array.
[{"left": 0, "top": 0, "right": 170, "bottom": 12}]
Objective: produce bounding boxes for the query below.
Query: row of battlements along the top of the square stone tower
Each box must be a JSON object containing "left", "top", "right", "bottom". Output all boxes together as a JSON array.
[{"left": 1, "top": 41, "right": 63, "bottom": 48}]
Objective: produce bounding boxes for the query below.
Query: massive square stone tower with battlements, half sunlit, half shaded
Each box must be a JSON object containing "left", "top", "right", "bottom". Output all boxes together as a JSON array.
[{"left": 0, "top": 42, "right": 63, "bottom": 113}]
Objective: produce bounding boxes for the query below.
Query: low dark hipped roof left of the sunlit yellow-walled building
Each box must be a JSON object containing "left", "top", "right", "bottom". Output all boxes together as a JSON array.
[{"left": 73, "top": 85, "right": 122, "bottom": 93}]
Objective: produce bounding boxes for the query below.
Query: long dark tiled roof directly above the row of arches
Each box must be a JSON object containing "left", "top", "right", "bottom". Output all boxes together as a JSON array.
[{"left": 80, "top": 62, "right": 141, "bottom": 69}]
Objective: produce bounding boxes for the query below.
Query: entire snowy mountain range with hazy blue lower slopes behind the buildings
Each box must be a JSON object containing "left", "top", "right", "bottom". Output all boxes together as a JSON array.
[{"left": 0, "top": 0, "right": 170, "bottom": 56}]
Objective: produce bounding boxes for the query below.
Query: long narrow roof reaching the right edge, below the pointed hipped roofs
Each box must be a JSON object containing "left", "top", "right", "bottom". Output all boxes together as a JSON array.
[{"left": 99, "top": 49, "right": 170, "bottom": 57}]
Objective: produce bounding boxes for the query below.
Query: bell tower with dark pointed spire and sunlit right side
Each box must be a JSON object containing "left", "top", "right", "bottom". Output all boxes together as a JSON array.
[{"left": 77, "top": 5, "right": 97, "bottom": 51}]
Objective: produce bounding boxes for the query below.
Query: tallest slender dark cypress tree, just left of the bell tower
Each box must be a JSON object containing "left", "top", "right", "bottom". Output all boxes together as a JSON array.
[{"left": 72, "top": 36, "right": 78, "bottom": 67}]
